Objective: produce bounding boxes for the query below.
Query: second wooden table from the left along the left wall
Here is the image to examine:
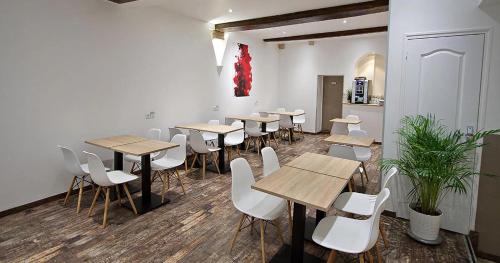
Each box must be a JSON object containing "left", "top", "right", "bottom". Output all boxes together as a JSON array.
[{"left": 175, "top": 123, "right": 243, "bottom": 173}]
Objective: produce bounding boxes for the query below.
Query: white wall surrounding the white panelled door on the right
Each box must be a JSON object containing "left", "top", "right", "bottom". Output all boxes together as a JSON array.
[{"left": 383, "top": 0, "right": 500, "bottom": 231}]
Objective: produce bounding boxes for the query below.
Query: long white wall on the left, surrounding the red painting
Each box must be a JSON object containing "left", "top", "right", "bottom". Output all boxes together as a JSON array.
[{"left": 0, "top": 0, "right": 277, "bottom": 211}]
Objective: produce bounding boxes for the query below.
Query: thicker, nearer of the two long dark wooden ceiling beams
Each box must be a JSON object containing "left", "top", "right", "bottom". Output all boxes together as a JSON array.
[{"left": 215, "top": 0, "right": 389, "bottom": 32}]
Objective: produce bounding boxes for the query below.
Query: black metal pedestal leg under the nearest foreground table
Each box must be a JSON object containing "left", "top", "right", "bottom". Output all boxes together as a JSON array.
[{"left": 270, "top": 203, "right": 323, "bottom": 263}]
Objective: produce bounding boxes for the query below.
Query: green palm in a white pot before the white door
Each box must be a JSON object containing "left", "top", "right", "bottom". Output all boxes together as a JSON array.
[{"left": 382, "top": 115, "right": 500, "bottom": 244}]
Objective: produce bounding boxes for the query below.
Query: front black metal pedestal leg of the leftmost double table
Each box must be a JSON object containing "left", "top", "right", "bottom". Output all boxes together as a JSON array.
[{"left": 125, "top": 154, "right": 170, "bottom": 214}]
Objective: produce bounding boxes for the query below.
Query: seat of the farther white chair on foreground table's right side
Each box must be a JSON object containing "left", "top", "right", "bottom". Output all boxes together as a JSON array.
[{"left": 333, "top": 192, "right": 377, "bottom": 216}]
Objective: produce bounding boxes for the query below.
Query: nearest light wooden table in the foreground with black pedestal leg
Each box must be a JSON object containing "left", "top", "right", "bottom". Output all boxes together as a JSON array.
[{"left": 252, "top": 158, "right": 355, "bottom": 262}]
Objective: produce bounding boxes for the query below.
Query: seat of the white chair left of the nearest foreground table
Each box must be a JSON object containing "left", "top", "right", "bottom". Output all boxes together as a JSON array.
[{"left": 236, "top": 190, "right": 286, "bottom": 220}]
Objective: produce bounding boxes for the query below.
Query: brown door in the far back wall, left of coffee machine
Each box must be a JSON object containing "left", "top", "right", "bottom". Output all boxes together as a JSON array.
[{"left": 321, "top": 76, "right": 344, "bottom": 132}]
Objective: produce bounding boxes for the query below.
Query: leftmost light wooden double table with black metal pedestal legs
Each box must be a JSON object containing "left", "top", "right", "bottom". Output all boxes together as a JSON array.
[{"left": 85, "top": 135, "right": 179, "bottom": 214}]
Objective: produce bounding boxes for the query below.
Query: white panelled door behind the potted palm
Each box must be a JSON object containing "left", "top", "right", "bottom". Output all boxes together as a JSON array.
[{"left": 401, "top": 34, "right": 484, "bottom": 234}]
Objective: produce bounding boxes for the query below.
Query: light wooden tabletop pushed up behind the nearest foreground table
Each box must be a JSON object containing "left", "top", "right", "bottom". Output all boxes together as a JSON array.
[{"left": 285, "top": 152, "right": 361, "bottom": 180}]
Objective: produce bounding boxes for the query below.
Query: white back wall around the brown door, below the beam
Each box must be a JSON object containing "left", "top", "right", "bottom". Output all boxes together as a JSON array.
[{"left": 279, "top": 33, "right": 387, "bottom": 132}]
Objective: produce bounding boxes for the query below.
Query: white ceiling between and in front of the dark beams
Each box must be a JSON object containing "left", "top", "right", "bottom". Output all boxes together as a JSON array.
[{"left": 126, "top": 0, "right": 388, "bottom": 39}]
